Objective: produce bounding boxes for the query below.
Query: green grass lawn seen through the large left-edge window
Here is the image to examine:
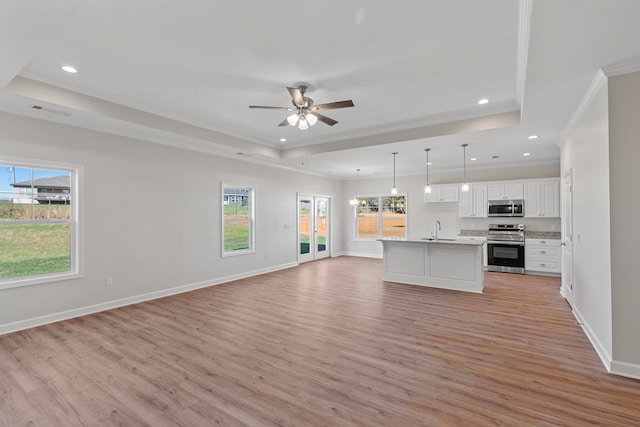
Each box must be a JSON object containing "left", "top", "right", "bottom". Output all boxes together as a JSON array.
[{"left": 0, "top": 224, "right": 71, "bottom": 279}]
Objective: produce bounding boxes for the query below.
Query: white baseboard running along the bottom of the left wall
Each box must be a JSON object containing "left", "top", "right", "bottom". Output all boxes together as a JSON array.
[{"left": 0, "top": 262, "right": 298, "bottom": 335}]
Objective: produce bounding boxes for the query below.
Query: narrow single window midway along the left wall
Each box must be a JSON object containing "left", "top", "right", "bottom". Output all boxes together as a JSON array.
[{"left": 222, "top": 184, "right": 255, "bottom": 256}]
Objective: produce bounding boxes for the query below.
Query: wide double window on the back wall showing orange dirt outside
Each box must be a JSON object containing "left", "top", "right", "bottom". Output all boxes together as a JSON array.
[{"left": 355, "top": 195, "right": 407, "bottom": 239}]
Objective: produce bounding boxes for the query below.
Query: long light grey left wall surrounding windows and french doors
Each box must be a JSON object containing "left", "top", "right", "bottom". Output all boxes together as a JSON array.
[{"left": 0, "top": 113, "right": 343, "bottom": 333}]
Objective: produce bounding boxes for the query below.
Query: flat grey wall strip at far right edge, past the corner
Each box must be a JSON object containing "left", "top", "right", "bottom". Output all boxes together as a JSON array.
[{"left": 609, "top": 72, "right": 640, "bottom": 379}]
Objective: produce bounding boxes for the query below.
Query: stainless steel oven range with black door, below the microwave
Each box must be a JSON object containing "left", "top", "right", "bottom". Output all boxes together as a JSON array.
[{"left": 487, "top": 224, "right": 524, "bottom": 274}]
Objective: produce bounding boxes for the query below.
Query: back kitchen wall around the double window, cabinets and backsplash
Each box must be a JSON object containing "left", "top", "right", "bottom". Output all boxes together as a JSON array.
[{"left": 342, "top": 165, "right": 560, "bottom": 257}]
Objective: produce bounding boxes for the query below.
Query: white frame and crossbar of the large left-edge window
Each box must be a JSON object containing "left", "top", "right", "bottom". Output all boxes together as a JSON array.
[{"left": 0, "top": 156, "right": 84, "bottom": 290}]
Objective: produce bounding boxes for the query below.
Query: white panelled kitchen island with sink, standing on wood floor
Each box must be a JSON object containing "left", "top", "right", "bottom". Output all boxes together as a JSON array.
[{"left": 378, "top": 239, "right": 485, "bottom": 293}]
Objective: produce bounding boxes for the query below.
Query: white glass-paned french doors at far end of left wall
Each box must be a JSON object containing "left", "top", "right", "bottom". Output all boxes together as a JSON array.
[{"left": 298, "top": 194, "right": 331, "bottom": 262}]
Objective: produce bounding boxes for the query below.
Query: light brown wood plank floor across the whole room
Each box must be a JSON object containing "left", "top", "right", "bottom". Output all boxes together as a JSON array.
[{"left": 0, "top": 257, "right": 640, "bottom": 427}]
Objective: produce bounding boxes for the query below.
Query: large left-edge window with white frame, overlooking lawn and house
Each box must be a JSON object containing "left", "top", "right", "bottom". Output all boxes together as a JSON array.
[{"left": 0, "top": 159, "right": 81, "bottom": 288}]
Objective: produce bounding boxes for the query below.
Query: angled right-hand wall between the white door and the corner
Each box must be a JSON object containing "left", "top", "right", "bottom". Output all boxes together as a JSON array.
[{"left": 561, "top": 78, "right": 612, "bottom": 366}]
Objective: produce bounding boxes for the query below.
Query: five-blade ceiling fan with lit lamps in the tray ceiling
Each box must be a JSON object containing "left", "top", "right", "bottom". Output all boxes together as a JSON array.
[{"left": 249, "top": 85, "right": 353, "bottom": 130}]
